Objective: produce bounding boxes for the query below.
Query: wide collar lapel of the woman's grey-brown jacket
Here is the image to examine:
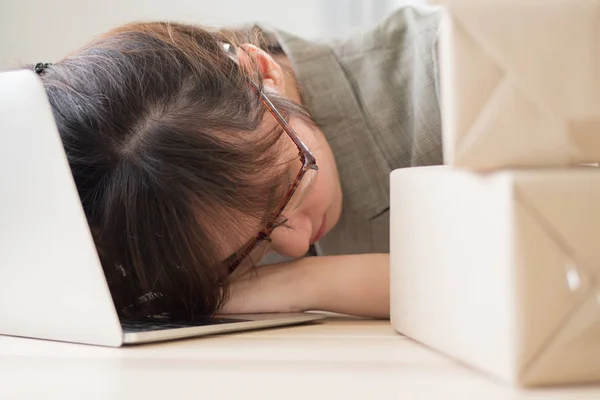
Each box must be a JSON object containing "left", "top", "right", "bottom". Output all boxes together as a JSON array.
[{"left": 272, "top": 30, "right": 391, "bottom": 218}]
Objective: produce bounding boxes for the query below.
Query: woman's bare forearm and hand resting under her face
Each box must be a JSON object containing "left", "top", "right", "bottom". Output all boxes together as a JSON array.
[{"left": 222, "top": 254, "right": 390, "bottom": 318}]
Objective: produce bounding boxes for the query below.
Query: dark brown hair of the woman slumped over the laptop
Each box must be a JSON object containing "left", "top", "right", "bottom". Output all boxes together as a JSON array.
[{"left": 30, "top": 22, "right": 302, "bottom": 315}]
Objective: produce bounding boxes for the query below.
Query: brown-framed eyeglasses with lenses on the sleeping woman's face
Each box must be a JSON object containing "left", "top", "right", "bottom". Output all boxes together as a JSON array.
[{"left": 223, "top": 43, "right": 319, "bottom": 274}]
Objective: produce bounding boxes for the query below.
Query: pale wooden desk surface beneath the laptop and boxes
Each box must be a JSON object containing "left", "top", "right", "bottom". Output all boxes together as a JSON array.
[{"left": 0, "top": 316, "right": 600, "bottom": 400}]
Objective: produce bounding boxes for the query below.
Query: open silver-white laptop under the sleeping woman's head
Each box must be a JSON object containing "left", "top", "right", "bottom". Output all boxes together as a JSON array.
[{"left": 0, "top": 70, "right": 325, "bottom": 347}]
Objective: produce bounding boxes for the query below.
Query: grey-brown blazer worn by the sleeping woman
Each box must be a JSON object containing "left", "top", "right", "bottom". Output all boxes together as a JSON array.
[{"left": 264, "top": 6, "right": 443, "bottom": 255}]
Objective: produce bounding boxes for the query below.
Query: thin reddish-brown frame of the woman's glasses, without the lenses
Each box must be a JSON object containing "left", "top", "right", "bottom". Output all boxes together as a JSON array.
[{"left": 222, "top": 43, "right": 319, "bottom": 274}]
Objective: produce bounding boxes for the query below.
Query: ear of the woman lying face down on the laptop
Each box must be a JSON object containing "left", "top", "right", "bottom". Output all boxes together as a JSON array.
[{"left": 238, "top": 43, "right": 286, "bottom": 96}]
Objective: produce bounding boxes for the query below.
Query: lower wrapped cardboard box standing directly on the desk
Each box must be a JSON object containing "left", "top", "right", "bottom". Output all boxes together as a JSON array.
[{"left": 390, "top": 166, "right": 600, "bottom": 386}]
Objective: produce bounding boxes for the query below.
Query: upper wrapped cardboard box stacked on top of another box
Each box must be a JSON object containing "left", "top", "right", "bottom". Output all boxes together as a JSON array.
[{"left": 432, "top": 0, "right": 600, "bottom": 170}]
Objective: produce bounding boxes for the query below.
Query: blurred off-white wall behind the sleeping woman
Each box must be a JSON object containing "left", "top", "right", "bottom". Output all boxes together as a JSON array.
[{"left": 0, "top": 0, "right": 425, "bottom": 70}]
